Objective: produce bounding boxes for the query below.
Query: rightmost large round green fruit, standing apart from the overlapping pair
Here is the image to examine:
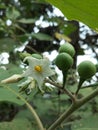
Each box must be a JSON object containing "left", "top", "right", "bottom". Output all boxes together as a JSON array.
[{"left": 78, "top": 60, "right": 96, "bottom": 80}]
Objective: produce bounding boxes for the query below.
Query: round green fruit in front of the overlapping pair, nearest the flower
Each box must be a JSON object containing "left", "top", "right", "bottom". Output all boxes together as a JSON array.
[{"left": 55, "top": 53, "right": 73, "bottom": 71}]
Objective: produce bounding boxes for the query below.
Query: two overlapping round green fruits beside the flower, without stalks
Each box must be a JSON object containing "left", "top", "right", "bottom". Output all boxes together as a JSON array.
[{"left": 55, "top": 43, "right": 75, "bottom": 72}]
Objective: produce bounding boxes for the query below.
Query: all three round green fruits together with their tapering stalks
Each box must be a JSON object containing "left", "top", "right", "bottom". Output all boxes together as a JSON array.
[{"left": 55, "top": 43, "right": 97, "bottom": 93}]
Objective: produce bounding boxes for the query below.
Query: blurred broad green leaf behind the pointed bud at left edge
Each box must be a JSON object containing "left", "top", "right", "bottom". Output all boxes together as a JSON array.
[{"left": 0, "top": 65, "right": 24, "bottom": 105}]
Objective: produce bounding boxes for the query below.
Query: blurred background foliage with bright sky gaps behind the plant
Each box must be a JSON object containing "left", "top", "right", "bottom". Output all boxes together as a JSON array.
[{"left": 0, "top": 0, "right": 98, "bottom": 130}]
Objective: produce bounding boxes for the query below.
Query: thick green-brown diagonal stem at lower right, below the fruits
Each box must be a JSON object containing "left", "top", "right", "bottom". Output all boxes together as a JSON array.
[{"left": 48, "top": 88, "right": 98, "bottom": 130}]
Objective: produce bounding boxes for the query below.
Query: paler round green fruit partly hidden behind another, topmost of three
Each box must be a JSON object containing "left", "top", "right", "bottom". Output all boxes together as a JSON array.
[{"left": 58, "top": 42, "right": 75, "bottom": 57}]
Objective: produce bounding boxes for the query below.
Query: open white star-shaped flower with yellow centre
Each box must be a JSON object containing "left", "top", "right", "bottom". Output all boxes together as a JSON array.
[{"left": 23, "top": 56, "right": 54, "bottom": 90}]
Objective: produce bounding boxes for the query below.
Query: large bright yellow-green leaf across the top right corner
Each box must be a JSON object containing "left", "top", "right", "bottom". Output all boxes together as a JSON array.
[{"left": 46, "top": 0, "right": 98, "bottom": 30}]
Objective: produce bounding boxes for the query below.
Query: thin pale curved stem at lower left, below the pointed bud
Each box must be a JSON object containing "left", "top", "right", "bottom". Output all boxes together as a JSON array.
[{"left": 0, "top": 84, "right": 45, "bottom": 130}]
